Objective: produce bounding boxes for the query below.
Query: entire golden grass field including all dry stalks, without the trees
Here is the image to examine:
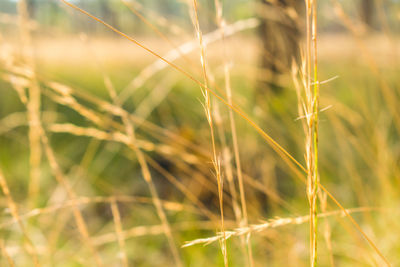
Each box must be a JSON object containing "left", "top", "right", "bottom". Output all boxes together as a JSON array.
[{"left": 0, "top": 0, "right": 400, "bottom": 266}]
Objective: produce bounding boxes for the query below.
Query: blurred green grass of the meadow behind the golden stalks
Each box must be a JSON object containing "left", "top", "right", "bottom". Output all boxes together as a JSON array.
[{"left": 0, "top": 0, "right": 400, "bottom": 266}]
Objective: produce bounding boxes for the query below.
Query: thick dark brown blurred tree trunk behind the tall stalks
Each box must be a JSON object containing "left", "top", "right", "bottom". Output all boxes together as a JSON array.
[{"left": 259, "top": 0, "right": 304, "bottom": 92}]
